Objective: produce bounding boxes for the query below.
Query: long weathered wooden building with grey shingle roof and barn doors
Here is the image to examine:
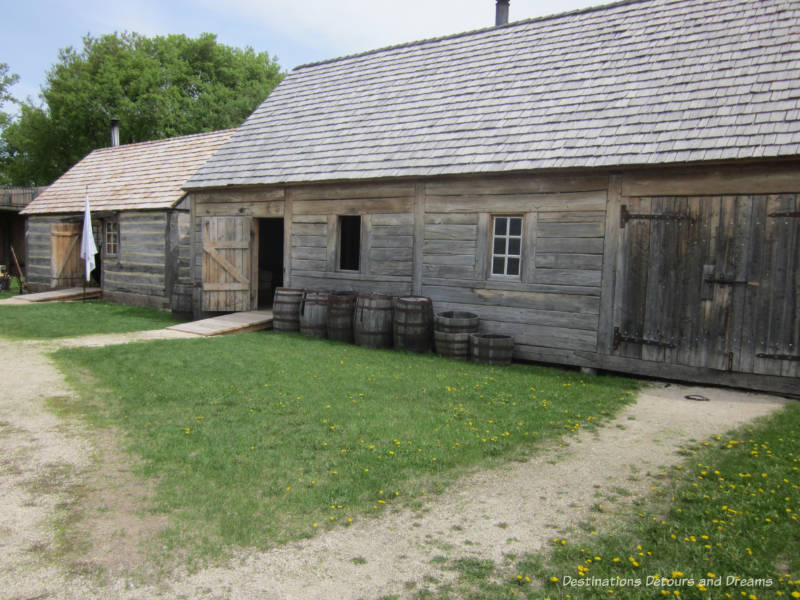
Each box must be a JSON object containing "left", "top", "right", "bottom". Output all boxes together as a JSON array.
[{"left": 185, "top": 0, "right": 800, "bottom": 394}]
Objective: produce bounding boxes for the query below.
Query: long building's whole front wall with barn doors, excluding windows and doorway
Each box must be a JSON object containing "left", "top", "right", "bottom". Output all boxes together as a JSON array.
[{"left": 189, "top": 164, "right": 800, "bottom": 391}]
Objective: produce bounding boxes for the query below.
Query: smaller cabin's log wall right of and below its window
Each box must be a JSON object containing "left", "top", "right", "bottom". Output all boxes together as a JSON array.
[{"left": 103, "top": 212, "right": 170, "bottom": 307}]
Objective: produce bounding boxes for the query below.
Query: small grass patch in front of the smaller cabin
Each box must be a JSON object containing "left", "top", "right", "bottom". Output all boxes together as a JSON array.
[{"left": 0, "top": 300, "right": 177, "bottom": 339}]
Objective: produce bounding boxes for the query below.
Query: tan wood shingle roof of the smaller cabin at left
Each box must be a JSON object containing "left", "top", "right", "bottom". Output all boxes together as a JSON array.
[{"left": 22, "top": 129, "right": 234, "bottom": 215}]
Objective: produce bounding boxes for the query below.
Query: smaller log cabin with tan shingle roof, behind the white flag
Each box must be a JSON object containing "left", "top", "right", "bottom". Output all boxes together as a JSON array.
[{"left": 22, "top": 130, "right": 232, "bottom": 312}]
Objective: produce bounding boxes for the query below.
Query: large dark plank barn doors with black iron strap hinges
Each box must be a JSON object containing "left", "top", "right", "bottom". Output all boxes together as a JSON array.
[{"left": 614, "top": 196, "right": 800, "bottom": 376}]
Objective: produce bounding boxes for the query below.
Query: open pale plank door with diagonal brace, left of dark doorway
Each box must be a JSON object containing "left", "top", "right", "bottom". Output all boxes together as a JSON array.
[{"left": 201, "top": 217, "right": 256, "bottom": 312}]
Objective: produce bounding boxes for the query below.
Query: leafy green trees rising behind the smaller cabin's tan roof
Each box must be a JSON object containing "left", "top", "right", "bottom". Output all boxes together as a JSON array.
[{"left": 0, "top": 33, "right": 283, "bottom": 185}]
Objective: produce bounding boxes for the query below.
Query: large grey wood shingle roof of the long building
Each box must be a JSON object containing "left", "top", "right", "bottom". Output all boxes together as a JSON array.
[{"left": 186, "top": 0, "right": 800, "bottom": 189}]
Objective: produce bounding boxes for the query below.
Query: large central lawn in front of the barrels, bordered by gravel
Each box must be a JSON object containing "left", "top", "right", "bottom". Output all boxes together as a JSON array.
[{"left": 55, "top": 332, "right": 638, "bottom": 556}]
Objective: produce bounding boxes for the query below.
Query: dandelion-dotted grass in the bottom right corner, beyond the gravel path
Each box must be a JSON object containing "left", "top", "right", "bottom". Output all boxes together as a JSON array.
[{"left": 419, "top": 403, "right": 800, "bottom": 600}]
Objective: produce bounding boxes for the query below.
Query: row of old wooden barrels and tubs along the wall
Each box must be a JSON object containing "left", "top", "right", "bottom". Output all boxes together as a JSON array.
[{"left": 272, "top": 288, "right": 514, "bottom": 364}]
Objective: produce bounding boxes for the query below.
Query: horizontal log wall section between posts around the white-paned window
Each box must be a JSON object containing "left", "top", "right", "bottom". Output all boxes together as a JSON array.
[{"left": 422, "top": 183, "right": 608, "bottom": 365}]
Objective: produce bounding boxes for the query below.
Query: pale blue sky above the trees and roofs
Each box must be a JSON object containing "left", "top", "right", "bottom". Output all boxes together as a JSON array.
[{"left": 0, "top": 0, "right": 603, "bottom": 112}]
